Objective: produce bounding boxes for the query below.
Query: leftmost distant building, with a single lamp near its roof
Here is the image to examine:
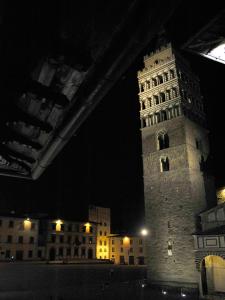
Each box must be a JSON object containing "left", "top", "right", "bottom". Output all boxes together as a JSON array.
[{"left": 0, "top": 216, "right": 39, "bottom": 261}]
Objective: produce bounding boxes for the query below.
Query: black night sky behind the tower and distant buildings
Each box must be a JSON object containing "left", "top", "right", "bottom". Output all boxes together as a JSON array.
[{"left": 0, "top": 1, "right": 225, "bottom": 231}]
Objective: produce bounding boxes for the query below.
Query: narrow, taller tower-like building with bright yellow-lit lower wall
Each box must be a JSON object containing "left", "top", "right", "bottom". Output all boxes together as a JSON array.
[{"left": 89, "top": 206, "right": 111, "bottom": 259}]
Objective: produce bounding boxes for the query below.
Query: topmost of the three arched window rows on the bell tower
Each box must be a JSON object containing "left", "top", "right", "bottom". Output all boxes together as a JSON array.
[{"left": 139, "top": 69, "right": 175, "bottom": 93}]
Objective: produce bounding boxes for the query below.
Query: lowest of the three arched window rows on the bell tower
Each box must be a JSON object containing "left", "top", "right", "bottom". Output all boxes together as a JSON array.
[{"left": 141, "top": 105, "right": 181, "bottom": 128}]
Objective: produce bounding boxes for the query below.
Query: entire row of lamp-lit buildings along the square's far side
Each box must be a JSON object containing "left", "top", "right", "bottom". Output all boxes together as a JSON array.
[{"left": 0, "top": 205, "right": 146, "bottom": 265}]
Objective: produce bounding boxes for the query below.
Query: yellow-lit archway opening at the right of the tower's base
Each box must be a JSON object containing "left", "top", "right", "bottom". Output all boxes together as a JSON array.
[{"left": 201, "top": 255, "right": 225, "bottom": 295}]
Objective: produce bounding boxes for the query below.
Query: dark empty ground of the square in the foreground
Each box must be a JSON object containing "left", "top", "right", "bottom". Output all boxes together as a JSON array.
[{"left": 0, "top": 263, "right": 197, "bottom": 300}]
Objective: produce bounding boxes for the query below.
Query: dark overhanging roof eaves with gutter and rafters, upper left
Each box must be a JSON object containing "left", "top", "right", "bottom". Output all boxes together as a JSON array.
[{"left": 0, "top": 0, "right": 222, "bottom": 179}]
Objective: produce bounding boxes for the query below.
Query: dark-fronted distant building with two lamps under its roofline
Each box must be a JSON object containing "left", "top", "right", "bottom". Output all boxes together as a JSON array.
[{"left": 38, "top": 220, "right": 97, "bottom": 260}]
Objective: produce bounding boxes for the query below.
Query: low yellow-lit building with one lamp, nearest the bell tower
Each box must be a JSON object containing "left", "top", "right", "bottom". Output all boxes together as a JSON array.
[{"left": 109, "top": 234, "right": 146, "bottom": 265}]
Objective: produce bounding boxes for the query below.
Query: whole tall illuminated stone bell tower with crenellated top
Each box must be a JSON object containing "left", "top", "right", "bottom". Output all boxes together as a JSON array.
[{"left": 138, "top": 44, "right": 213, "bottom": 288}]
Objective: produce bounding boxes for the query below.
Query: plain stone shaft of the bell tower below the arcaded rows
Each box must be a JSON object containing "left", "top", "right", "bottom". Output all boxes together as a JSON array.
[{"left": 142, "top": 116, "right": 208, "bottom": 287}]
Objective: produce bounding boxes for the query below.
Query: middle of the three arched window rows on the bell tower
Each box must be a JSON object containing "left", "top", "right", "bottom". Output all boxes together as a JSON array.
[{"left": 140, "top": 87, "right": 179, "bottom": 110}]
